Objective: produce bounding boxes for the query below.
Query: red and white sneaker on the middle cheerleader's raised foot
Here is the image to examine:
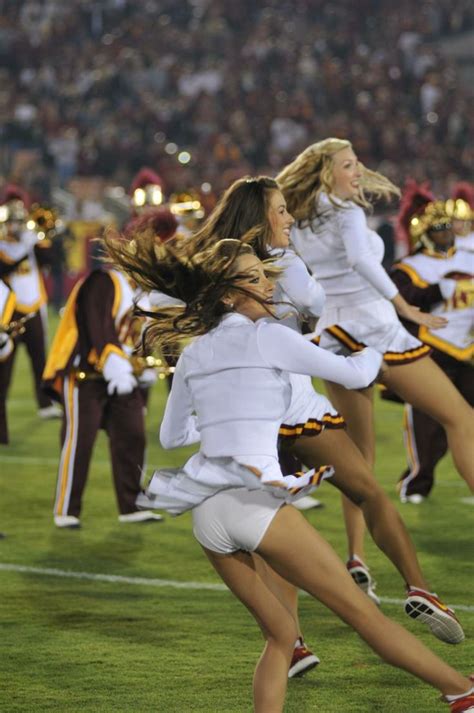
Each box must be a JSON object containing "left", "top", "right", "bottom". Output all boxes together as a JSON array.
[{"left": 405, "top": 589, "right": 468, "bottom": 644}]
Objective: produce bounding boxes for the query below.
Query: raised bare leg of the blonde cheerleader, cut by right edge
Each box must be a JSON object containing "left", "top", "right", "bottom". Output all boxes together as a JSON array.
[{"left": 384, "top": 357, "right": 474, "bottom": 491}]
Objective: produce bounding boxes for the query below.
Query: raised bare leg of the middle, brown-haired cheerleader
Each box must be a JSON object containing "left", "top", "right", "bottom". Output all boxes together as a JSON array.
[{"left": 293, "top": 429, "right": 429, "bottom": 591}]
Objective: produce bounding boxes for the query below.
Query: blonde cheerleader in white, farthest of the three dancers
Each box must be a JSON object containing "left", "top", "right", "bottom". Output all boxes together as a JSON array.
[{"left": 277, "top": 139, "right": 474, "bottom": 588}]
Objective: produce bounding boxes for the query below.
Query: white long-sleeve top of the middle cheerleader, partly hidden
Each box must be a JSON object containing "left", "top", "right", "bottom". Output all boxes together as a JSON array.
[{"left": 269, "top": 248, "right": 326, "bottom": 331}]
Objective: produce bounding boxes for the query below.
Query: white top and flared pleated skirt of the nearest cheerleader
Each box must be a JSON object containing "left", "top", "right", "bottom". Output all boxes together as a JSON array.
[{"left": 143, "top": 313, "right": 382, "bottom": 551}]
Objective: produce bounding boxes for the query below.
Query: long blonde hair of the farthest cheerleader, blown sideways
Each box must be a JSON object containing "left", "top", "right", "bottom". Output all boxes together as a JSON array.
[{"left": 276, "top": 138, "right": 400, "bottom": 224}]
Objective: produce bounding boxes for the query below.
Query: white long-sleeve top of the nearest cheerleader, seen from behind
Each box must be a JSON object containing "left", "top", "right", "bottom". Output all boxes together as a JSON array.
[{"left": 160, "top": 313, "right": 382, "bottom": 458}]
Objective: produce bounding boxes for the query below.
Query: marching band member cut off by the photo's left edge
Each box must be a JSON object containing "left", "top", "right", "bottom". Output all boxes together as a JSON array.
[{"left": 0, "top": 185, "right": 62, "bottom": 426}]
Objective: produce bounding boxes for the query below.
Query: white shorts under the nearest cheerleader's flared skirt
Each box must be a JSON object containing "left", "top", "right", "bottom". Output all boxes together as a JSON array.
[{"left": 192, "top": 488, "right": 285, "bottom": 554}]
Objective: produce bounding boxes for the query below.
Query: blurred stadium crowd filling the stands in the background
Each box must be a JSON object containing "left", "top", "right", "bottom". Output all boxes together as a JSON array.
[{"left": 0, "top": 0, "right": 474, "bottom": 200}]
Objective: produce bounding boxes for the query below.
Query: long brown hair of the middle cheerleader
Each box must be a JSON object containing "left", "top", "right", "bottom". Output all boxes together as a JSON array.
[{"left": 194, "top": 176, "right": 280, "bottom": 260}]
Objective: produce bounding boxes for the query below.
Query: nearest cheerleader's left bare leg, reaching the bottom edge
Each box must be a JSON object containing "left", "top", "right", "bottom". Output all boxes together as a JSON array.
[{"left": 203, "top": 548, "right": 297, "bottom": 713}]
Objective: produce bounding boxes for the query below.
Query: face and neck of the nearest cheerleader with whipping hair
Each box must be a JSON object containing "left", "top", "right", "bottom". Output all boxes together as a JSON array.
[{"left": 225, "top": 249, "right": 274, "bottom": 322}]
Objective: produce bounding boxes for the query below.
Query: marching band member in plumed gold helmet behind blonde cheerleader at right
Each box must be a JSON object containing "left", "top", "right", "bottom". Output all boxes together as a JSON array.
[{"left": 391, "top": 181, "right": 474, "bottom": 504}]
